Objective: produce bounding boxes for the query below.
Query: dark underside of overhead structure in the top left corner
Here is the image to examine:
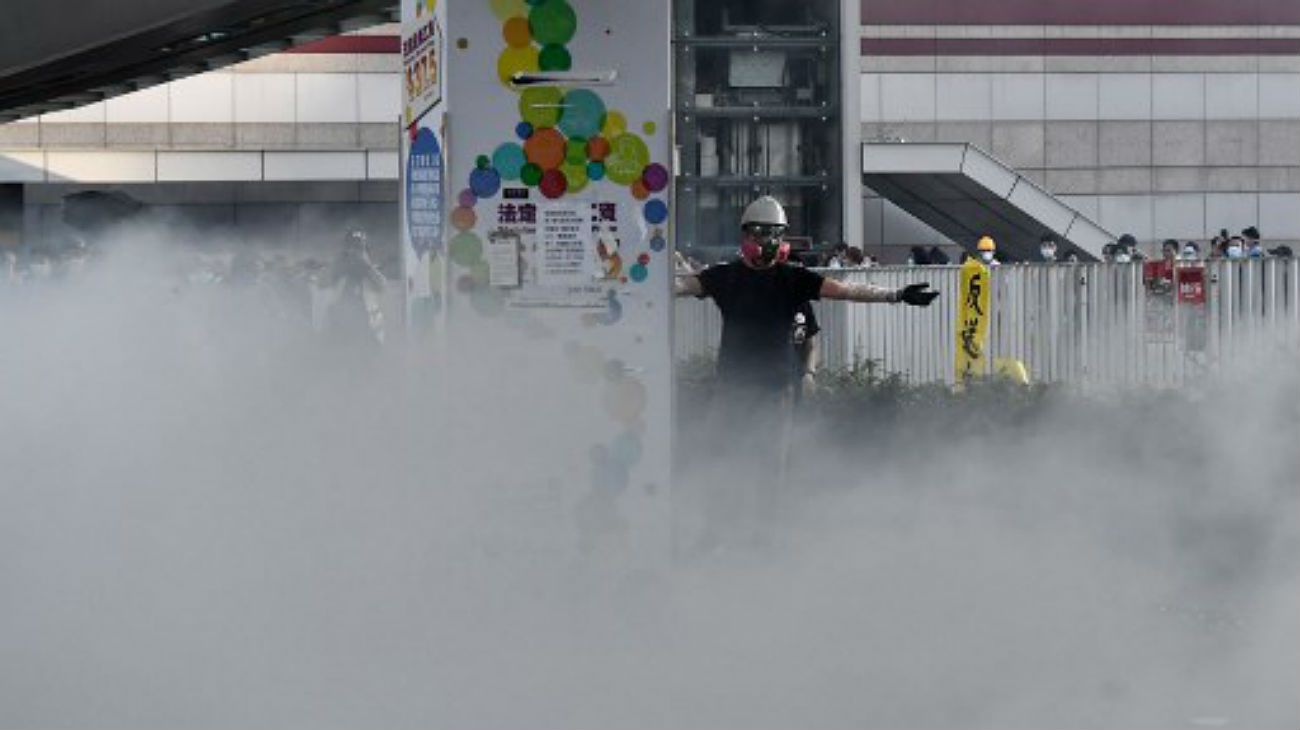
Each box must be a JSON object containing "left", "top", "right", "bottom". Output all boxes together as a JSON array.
[{"left": 0, "top": 0, "right": 399, "bottom": 123}]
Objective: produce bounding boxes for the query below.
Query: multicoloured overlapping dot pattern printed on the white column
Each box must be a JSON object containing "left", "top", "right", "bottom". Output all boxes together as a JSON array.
[{"left": 470, "top": 0, "right": 672, "bottom": 511}]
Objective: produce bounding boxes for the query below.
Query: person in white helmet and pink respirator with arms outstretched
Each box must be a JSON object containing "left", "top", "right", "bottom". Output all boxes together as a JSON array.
[{"left": 676, "top": 196, "right": 939, "bottom": 543}]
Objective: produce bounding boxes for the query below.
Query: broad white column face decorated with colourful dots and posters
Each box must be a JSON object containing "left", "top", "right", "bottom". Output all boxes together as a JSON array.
[{"left": 447, "top": 0, "right": 672, "bottom": 552}]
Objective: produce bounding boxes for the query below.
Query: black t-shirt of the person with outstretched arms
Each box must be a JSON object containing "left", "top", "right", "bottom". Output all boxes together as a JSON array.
[{"left": 699, "top": 262, "right": 823, "bottom": 387}]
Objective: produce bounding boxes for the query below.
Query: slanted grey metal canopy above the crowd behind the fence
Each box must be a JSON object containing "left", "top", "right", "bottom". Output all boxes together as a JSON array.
[{"left": 862, "top": 142, "right": 1114, "bottom": 261}]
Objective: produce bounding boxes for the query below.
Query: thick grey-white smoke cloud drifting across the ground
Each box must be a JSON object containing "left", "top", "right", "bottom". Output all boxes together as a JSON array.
[{"left": 0, "top": 229, "right": 1300, "bottom": 729}]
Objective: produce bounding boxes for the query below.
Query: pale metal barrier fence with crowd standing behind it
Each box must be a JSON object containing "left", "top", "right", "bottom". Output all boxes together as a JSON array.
[{"left": 675, "top": 258, "right": 1300, "bottom": 386}]
